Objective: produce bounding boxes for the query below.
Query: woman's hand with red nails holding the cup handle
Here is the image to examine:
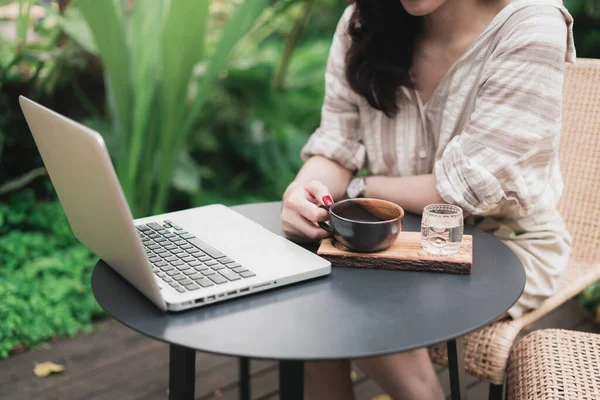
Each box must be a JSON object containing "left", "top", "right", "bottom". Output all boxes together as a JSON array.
[{"left": 281, "top": 181, "right": 333, "bottom": 242}]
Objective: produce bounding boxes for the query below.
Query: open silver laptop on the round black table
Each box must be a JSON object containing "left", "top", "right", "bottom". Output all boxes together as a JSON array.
[{"left": 19, "top": 96, "right": 331, "bottom": 311}]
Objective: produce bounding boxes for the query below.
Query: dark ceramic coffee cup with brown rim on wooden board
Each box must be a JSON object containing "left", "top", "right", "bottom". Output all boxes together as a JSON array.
[{"left": 319, "top": 198, "right": 404, "bottom": 253}]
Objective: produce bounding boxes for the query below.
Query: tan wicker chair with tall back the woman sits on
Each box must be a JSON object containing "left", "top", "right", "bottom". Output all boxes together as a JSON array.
[{"left": 430, "top": 59, "right": 600, "bottom": 399}]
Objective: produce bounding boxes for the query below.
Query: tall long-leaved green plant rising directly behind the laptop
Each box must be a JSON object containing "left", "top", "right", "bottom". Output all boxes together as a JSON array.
[{"left": 65, "top": 0, "right": 267, "bottom": 216}]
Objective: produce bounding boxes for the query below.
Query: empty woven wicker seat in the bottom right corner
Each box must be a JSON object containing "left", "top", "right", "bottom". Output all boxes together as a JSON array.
[{"left": 508, "top": 329, "right": 600, "bottom": 400}]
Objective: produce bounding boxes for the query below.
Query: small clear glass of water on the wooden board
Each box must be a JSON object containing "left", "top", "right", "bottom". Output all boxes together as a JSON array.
[{"left": 421, "top": 204, "right": 463, "bottom": 255}]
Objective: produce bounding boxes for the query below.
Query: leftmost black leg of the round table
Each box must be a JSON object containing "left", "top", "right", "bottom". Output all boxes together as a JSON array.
[{"left": 169, "top": 344, "right": 196, "bottom": 400}]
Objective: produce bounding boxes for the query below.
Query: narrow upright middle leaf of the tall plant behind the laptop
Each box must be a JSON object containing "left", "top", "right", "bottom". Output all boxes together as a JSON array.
[{"left": 128, "top": 0, "right": 164, "bottom": 184}]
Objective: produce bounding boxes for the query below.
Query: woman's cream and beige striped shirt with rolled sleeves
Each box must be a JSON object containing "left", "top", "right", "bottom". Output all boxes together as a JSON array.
[{"left": 302, "top": 0, "right": 575, "bottom": 220}]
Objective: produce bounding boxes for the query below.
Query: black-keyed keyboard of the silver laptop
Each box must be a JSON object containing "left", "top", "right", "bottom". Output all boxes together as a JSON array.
[{"left": 136, "top": 220, "right": 255, "bottom": 293}]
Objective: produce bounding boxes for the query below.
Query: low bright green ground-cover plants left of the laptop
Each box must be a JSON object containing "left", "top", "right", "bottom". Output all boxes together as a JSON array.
[{"left": 0, "top": 190, "right": 104, "bottom": 358}]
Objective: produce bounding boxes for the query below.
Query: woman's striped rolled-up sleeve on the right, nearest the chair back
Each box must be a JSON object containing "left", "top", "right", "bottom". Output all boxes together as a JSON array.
[{"left": 435, "top": 10, "right": 572, "bottom": 216}]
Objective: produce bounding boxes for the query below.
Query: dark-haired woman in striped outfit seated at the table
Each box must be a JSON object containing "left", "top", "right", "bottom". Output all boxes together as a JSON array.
[{"left": 281, "top": 0, "right": 575, "bottom": 399}]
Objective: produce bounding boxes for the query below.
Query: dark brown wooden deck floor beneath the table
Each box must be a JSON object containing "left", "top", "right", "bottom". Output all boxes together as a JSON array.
[{"left": 0, "top": 301, "right": 600, "bottom": 400}]
